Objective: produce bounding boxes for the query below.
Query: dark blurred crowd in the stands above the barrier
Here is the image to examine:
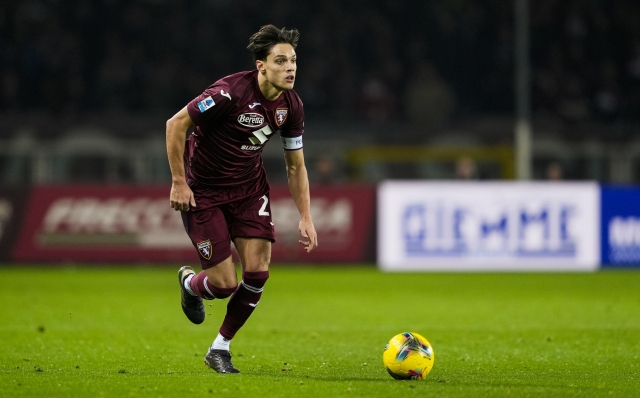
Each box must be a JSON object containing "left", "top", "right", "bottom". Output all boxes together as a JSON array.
[{"left": 0, "top": 0, "right": 640, "bottom": 126}]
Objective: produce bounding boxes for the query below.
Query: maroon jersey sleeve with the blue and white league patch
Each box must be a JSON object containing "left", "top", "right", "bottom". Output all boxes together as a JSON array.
[{"left": 187, "top": 81, "right": 233, "bottom": 126}]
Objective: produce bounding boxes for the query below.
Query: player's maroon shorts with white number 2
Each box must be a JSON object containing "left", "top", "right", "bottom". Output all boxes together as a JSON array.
[{"left": 182, "top": 181, "right": 275, "bottom": 269}]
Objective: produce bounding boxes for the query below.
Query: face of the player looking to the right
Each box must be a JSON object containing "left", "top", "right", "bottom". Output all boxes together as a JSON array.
[{"left": 258, "top": 43, "right": 298, "bottom": 90}]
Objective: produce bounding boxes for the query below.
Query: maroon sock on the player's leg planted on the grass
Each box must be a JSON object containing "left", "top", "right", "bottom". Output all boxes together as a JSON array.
[{"left": 220, "top": 271, "right": 269, "bottom": 340}]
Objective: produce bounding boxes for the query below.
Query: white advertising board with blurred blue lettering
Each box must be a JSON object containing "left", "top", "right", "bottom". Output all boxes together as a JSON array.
[{"left": 377, "top": 181, "right": 600, "bottom": 271}]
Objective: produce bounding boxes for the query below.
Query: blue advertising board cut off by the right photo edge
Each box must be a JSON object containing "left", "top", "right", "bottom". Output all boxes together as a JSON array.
[{"left": 600, "top": 186, "right": 640, "bottom": 267}]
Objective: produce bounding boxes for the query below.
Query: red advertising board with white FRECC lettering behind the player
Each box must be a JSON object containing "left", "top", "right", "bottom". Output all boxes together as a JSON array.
[{"left": 12, "top": 185, "right": 375, "bottom": 263}]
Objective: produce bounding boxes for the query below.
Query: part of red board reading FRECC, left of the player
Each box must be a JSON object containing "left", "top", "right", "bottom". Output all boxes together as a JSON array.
[{"left": 13, "top": 185, "right": 198, "bottom": 262}]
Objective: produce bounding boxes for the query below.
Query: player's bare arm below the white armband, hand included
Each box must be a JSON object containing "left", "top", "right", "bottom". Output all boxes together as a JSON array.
[{"left": 284, "top": 149, "right": 318, "bottom": 253}]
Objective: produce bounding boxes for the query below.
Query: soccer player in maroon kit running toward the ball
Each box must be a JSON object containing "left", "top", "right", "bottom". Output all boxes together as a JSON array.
[{"left": 166, "top": 25, "right": 318, "bottom": 373}]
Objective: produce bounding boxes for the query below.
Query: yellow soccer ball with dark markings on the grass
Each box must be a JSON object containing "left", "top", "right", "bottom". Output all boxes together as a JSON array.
[{"left": 382, "top": 332, "right": 435, "bottom": 380}]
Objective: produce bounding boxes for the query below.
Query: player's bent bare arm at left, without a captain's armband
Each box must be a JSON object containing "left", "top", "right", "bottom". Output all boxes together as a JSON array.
[{"left": 167, "top": 106, "right": 196, "bottom": 211}]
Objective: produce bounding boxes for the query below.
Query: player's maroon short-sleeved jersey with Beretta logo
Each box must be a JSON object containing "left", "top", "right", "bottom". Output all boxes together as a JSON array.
[{"left": 184, "top": 70, "right": 304, "bottom": 187}]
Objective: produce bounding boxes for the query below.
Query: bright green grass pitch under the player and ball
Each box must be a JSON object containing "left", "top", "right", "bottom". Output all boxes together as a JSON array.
[{"left": 0, "top": 266, "right": 640, "bottom": 398}]
